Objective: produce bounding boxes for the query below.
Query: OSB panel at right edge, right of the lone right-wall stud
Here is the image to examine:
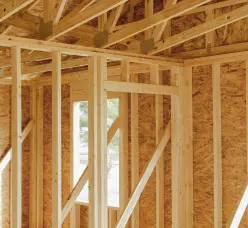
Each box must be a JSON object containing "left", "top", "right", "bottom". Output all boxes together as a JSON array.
[{"left": 221, "top": 62, "right": 248, "bottom": 227}]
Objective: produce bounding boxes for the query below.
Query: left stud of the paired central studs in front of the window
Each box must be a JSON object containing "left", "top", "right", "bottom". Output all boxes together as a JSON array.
[{"left": 88, "top": 56, "right": 100, "bottom": 227}]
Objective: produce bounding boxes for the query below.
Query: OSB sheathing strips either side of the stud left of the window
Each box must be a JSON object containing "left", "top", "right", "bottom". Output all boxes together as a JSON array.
[{"left": 43, "top": 85, "right": 70, "bottom": 228}]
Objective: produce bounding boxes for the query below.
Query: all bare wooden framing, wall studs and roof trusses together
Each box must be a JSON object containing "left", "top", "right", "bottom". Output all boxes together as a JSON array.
[{"left": 0, "top": 0, "right": 248, "bottom": 224}]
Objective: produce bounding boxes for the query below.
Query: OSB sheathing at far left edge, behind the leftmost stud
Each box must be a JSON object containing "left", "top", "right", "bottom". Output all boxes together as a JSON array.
[{"left": 0, "top": 85, "right": 30, "bottom": 228}]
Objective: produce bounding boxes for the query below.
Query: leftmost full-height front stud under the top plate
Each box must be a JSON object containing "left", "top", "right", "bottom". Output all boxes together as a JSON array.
[{"left": 11, "top": 47, "right": 22, "bottom": 228}]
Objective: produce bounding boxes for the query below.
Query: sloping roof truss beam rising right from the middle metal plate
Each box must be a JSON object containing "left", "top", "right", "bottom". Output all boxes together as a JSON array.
[{"left": 102, "top": 0, "right": 210, "bottom": 48}]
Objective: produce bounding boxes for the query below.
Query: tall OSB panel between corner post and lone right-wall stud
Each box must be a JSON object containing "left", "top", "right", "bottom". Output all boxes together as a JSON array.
[{"left": 193, "top": 66, "right": 214, "bottom": 228}]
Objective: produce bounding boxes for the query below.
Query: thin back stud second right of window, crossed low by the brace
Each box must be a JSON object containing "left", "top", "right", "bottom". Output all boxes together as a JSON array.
[{"left": 131, "top": 74, "right": 140, "bottom": 228}]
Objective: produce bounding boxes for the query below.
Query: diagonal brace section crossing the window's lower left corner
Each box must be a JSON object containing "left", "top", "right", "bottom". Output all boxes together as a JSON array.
[{"left": 61, "top": 166, "right": 89, "bottom": 222}]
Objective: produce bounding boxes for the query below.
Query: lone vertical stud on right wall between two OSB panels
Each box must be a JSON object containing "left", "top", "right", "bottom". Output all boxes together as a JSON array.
[{"left": 212, "top": 63, "right": 222, "bottom": 228}]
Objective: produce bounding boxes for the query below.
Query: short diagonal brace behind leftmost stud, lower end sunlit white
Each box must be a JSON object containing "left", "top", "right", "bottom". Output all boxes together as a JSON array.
[{"left": 0, "top": 120, "right": 33, "bottom": 174}]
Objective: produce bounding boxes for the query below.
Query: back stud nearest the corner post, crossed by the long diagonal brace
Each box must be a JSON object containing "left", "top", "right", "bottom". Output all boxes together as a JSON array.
[{"left": 150, "top": 65, "right": 165, "bottom": 228}]
